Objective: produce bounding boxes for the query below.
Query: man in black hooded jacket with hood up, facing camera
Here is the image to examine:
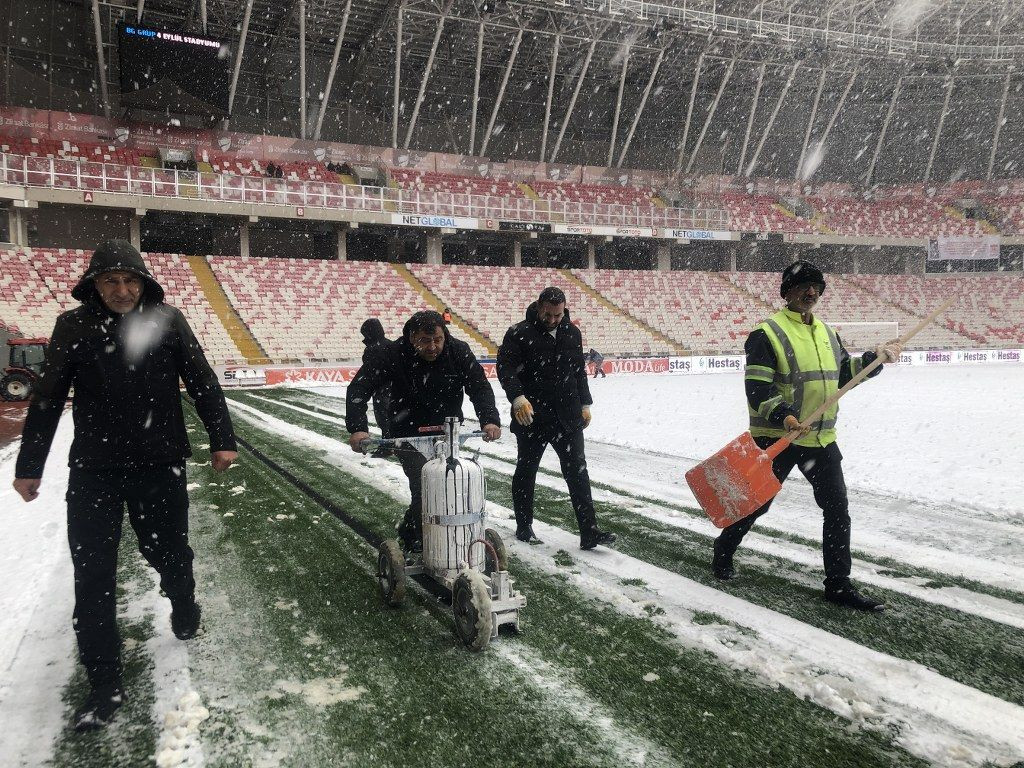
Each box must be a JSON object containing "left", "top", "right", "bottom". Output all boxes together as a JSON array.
[{"left": 14, "top": 240, "right": 238, "bottom": 730}]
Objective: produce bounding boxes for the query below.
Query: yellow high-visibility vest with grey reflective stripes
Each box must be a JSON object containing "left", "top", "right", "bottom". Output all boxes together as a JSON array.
[{"left": 745, "top": 309, "right": 860, "bottom": 447}]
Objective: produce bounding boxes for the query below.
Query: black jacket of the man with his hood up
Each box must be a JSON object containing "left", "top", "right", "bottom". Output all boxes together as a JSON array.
[{"left": 15, "top": 296, "right": 236, "bottom": 478}]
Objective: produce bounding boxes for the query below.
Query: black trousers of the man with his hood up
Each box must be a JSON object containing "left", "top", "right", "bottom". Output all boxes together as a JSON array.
[{"left": 67, "top": 465, "right": 196, "bottom": 686}]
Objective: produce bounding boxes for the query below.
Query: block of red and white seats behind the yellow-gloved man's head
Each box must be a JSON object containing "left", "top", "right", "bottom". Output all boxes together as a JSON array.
[{"left": 409, "top": 264, "right": 668, "bottom": 354}]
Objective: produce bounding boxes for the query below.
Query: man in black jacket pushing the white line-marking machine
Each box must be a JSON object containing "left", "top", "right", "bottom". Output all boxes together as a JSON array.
[{"left": 345, "top": 311, "right": 502, "bottom": 552}]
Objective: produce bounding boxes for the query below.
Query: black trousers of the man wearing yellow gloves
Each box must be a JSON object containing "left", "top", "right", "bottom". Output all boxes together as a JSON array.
[{"left": 512, "top": 422, "right": 597, "bottom": 534}]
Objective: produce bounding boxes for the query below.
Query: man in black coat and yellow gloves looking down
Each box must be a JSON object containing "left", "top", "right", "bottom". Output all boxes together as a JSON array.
[{"left": 498, "top": 288, "right": 615, "bottom": 549}]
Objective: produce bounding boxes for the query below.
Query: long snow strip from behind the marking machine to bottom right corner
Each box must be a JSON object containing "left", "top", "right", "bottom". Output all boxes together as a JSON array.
[{"left": 230, "top": 401, "right": 1024, "bottom": 768}]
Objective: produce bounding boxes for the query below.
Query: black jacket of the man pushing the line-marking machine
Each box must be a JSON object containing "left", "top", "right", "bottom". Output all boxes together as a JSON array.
[{"left": 345, "top": 319, "right": 501, "bottom": 437}]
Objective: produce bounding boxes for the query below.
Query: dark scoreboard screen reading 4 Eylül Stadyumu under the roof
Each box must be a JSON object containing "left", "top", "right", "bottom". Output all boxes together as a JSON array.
[{"left": 118, "top": 23, "right": 231, "bottom": 117}]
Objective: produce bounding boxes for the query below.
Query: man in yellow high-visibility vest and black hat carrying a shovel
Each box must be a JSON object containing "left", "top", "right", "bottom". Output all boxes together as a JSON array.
[{"left": 712, "top": 261, "right": 901, "bottom": 611}]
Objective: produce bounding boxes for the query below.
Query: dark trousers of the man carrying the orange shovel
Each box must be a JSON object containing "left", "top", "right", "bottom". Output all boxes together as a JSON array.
[{"left": 718, "top": 437, "right": 850, "bottom": 591}]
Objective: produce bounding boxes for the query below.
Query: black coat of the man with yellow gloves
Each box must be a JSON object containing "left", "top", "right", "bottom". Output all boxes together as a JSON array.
[{"left": 498, "top": 301, "right": 594, "bottom": 432}]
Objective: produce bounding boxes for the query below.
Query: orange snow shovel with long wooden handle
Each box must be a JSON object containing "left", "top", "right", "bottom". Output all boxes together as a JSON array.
[{"left": 686, "top": 297, "right": 956, "bottom": 528}]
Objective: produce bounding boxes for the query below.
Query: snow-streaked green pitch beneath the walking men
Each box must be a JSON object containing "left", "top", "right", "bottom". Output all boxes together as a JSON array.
[{"left": 0, "top": 367, "right": 1024, "bottom": 766}]
